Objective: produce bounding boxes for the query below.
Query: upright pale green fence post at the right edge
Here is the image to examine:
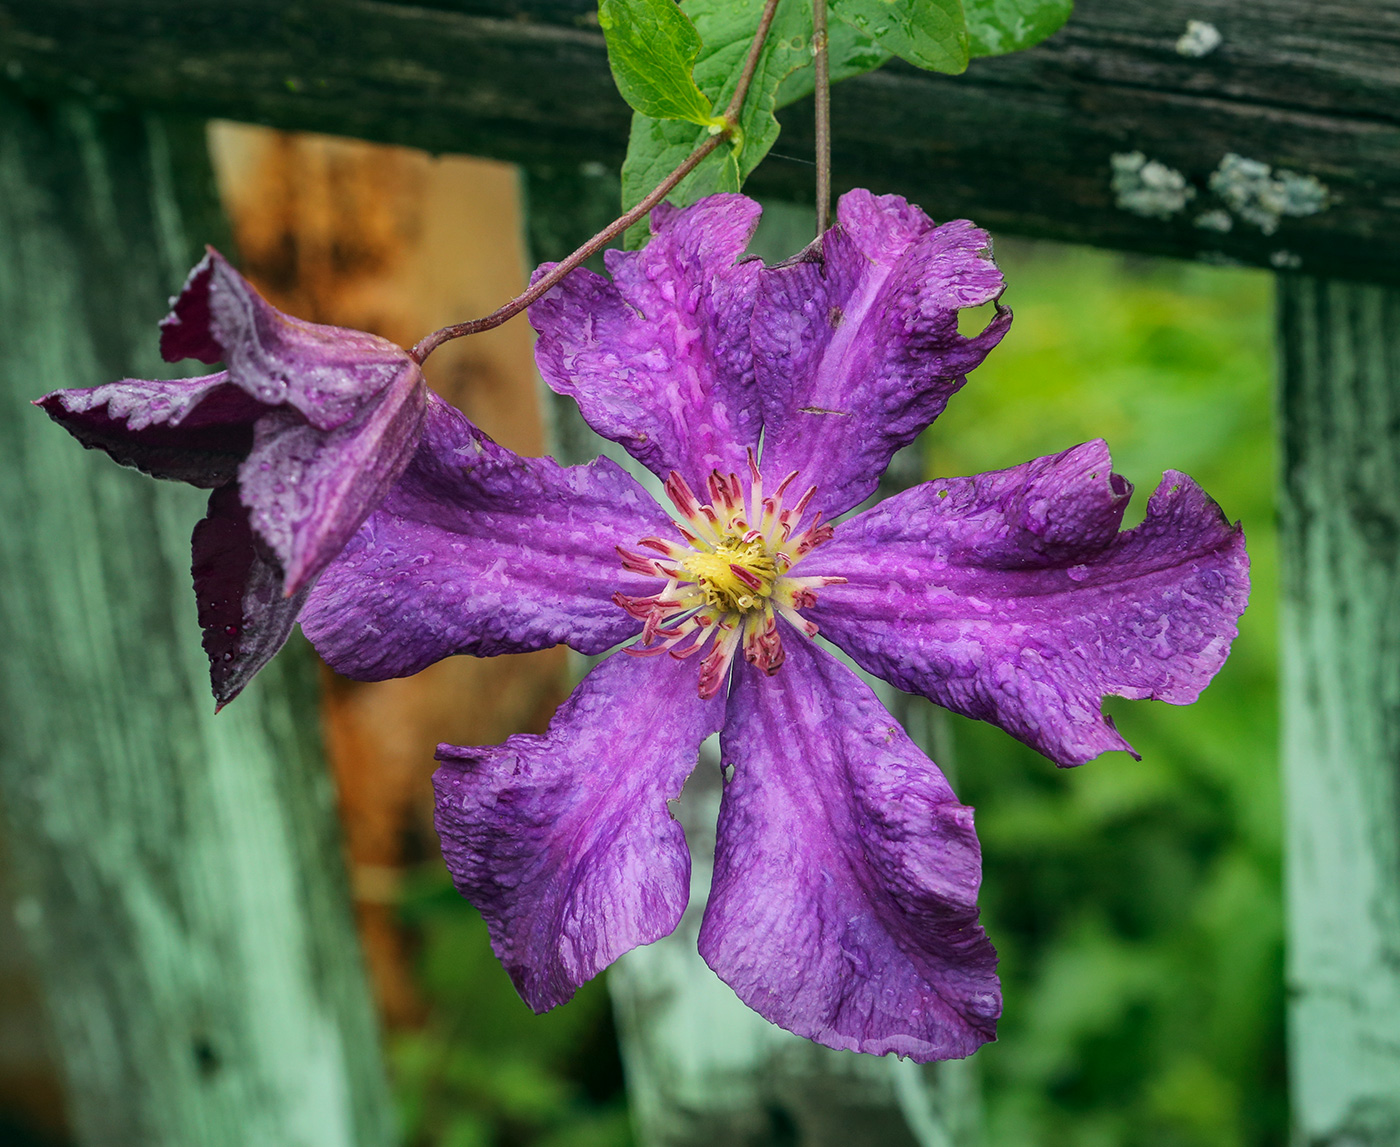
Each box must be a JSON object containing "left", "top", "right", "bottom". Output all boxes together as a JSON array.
[{"left": 1278, "top": 276, "right": 1400, "bottom": 1147}]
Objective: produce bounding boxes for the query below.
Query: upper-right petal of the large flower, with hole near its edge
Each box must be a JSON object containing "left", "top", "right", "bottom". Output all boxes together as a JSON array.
[{"left": 753, "top": 190, "right": 1011, "bottom": 518}]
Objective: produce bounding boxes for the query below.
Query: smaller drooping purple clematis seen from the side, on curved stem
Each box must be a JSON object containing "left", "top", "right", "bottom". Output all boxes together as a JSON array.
[{"left": 36, "top": 248, "right": 427, "bottom": 706}]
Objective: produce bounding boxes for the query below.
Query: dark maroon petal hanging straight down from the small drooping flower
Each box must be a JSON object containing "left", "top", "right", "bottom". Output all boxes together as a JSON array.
[{"left": 192, "top": 486, "right": 307, "bottom": 709}]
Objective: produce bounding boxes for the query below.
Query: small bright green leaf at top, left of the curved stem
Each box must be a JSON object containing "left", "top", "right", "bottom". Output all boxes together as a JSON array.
[{"left": 598, "top": 0, "right": 720, "bottom": 126}]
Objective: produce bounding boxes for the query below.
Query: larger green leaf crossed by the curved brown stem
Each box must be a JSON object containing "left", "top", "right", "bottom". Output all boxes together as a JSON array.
[{"left": 622, "top": 0, "right": 812, "bottom": 248}]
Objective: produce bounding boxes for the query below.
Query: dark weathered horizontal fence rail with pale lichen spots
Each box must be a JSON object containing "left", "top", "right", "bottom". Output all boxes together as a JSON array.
[{"left": 0, "top": 0, "right": 1400, "bottom": 281}]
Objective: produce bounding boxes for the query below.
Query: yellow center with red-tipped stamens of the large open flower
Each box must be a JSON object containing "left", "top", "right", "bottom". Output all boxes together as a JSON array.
[{"left": 613, "top": 451, "right": 846, "bottom": 697}]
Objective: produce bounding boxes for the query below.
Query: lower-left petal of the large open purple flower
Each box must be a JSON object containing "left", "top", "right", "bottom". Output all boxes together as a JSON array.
[{"left": 433, "top": 654, "right": 724, "bottom": 1011}]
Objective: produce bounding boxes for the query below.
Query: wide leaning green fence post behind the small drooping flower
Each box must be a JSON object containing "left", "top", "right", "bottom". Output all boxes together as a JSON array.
[{"left": 0, "top": 91, "right": 393, "bottom": 1147}]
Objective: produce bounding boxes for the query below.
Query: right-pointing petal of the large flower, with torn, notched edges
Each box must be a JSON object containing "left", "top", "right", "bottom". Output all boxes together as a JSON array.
[{"left": 802, "top": 441, "right": 1249, "bottom": 765}]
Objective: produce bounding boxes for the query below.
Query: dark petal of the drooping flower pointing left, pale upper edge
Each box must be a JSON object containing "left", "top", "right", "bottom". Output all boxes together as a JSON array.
[{"left": 35, "top": 371, "right": 266, "bottom": 489}]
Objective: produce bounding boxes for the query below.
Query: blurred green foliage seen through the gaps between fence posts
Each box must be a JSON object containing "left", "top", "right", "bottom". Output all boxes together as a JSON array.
[{"left": 392, "top": 235, "right": 1287, "bottom": 1147}]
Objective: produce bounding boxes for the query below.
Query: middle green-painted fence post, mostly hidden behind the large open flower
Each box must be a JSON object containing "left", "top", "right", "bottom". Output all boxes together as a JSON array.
[{"left": 525, "top": 165, "right": 979, "bottom": 1147}]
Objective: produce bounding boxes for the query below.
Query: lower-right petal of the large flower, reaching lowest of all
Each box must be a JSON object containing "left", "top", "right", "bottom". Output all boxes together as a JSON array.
[{"left": 700, "top": 630, "right": 1001, "bottom": 1060}]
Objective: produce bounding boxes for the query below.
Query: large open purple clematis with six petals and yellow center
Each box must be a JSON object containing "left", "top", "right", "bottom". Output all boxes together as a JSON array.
[{"left": 302, "top": 192, "right": 1247, "bottom": 1060}]
